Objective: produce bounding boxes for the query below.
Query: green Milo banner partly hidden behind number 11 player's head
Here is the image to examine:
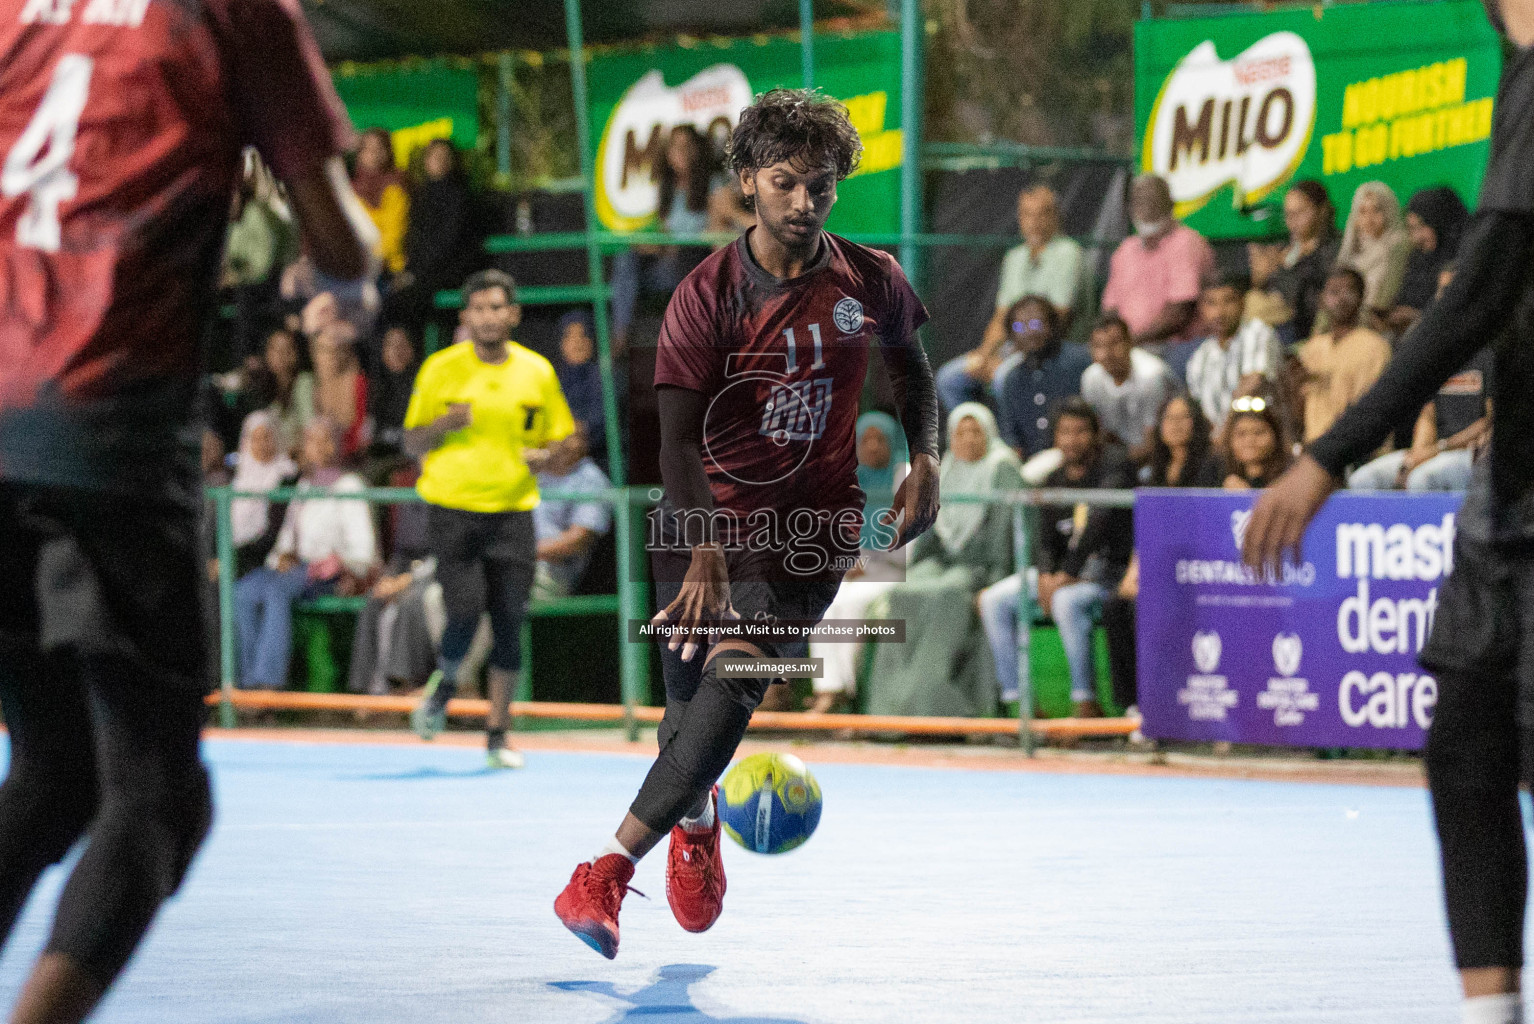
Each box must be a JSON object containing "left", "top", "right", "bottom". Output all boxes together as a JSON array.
[{"left": 588, "top": 32, "right": 900, "bottom": 233}]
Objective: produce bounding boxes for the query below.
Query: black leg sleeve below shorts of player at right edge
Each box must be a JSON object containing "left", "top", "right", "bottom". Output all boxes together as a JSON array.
[{"left": 1424, "top": 673, "right": 1528, "bottom": 970}]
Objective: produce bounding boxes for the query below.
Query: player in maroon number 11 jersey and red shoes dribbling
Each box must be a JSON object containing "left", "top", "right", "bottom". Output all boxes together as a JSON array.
[{"left": 554, "top": 89, "right": 937, "bottom": 960}]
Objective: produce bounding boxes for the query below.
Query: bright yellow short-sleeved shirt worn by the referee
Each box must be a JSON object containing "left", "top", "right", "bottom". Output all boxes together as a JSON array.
[{"left": 405, "top": 342, "right": 575, "bottom": 512}]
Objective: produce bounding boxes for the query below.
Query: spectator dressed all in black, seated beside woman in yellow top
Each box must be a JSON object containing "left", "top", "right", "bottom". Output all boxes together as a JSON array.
[{"left": 388, "top": 138, "right": 483, "bottom": 330}]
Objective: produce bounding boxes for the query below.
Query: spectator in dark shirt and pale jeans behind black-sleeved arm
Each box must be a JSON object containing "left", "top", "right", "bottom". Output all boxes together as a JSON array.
[{"left": 1347, "top": 348, "right": 1493, "bottom": 491}]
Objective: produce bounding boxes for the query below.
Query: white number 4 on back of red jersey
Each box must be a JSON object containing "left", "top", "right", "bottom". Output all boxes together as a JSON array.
[{"left": 0, "top": 54, "right": 95, "bottom": 253}]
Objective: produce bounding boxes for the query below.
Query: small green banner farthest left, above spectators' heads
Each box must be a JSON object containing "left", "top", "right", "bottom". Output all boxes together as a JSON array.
[{"left": 331, "top": 61, "right": 479, "bottom": 167}]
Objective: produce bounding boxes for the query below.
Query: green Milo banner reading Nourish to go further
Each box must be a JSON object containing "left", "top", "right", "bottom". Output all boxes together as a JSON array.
[{"left": 1135, "top": 0, "right": 1502, "bottom": 238}]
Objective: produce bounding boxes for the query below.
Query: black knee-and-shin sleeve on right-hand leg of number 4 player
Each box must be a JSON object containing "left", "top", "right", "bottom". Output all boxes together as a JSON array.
[{"left": 48, "top": 763, "right": 213, "bottom": 986}]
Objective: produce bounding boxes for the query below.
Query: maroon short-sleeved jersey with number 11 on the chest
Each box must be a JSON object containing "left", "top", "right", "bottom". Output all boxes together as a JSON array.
[{"left": 655, "top": 228, "right": 927, "bottom": 517}]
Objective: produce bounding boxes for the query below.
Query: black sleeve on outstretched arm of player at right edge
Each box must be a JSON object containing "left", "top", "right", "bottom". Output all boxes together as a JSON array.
[{"left": 1309, "top": 210, "right": 1534, "bottom": 477}]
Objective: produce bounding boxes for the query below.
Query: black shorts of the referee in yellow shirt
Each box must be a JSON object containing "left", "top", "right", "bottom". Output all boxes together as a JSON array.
[{"left": 426, "top": 504, "right": 538, "bottom": 621}]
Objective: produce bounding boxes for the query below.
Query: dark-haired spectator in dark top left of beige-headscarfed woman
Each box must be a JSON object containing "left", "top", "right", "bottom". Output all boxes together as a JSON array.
[{"left": 1246, "top": 178, "right": 1341, "bottom": 343}]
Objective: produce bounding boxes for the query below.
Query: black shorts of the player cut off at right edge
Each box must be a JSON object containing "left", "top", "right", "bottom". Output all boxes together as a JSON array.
[{"left": 1422, "top": 533, "right": 1534, "bottom": 680}]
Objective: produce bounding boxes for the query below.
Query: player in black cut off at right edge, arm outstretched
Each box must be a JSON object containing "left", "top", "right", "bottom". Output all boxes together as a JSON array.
[{"left": 1246, "top": 0, "right": 1534, "bottom": 1024}]
